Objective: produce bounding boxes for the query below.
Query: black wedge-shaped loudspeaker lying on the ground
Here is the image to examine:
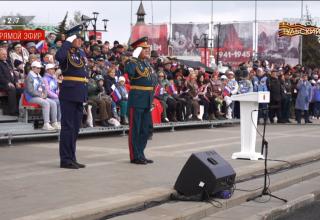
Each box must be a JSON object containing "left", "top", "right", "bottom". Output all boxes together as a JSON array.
[{"left": 174, "top": 150, "right": 236, "bottom": 196}]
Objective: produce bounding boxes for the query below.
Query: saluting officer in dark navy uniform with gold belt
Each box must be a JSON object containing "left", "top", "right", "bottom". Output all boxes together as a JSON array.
[{"left": 56, "top": 35, "right": 88, "bottom": 169}]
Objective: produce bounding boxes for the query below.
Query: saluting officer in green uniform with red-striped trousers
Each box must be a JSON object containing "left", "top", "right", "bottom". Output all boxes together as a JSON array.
[{"left": 125, "top": 37, "right": 154, "bottom": 164}]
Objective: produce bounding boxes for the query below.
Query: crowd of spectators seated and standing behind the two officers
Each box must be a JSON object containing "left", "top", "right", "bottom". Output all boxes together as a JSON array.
[{"left": 0, "top": 33, "right": 320, "bottom": 130}]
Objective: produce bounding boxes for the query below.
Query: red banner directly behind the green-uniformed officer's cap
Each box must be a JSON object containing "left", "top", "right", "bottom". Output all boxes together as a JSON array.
[{"left": 130, "top": 24, "right": 168, "bottom": 56}]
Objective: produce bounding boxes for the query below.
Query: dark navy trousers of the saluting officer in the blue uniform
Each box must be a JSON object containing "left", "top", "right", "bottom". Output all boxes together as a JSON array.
[{"left": 59, "top": 99, "right": 83, "bottom": 164}]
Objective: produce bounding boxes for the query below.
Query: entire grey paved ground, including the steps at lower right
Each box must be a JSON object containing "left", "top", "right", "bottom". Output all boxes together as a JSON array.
[{"left": 0, "top": 124, "right": 320, "bottom": 220}]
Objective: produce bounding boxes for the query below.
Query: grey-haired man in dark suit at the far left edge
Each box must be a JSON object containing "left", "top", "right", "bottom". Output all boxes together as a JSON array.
[{"left": 0, "top": 48, "right": 22, "bottom": 116}]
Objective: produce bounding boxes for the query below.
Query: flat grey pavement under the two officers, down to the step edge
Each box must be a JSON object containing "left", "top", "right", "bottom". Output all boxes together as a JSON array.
[{"left": 0, "top": 124, "right": 320, "bottom": 220}]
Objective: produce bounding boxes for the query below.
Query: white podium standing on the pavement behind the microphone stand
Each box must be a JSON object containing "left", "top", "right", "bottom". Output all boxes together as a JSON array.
[{"left": 231, "top": 92, "right": 270, "bottom": 160}]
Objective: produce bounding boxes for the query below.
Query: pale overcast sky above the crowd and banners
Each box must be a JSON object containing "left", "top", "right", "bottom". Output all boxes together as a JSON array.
[{"left": 0, "top": 1, "right": 320, "bottom": 43}]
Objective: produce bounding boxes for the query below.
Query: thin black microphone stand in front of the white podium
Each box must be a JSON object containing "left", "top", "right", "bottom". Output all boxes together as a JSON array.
[{"left": 247, "top": 110, "right": 288, "bottom": 202}]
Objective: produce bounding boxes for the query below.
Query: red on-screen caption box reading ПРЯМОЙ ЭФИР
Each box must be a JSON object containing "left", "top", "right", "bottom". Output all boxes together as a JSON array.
[{"left": 0, "top": 30, "right": 45, "bottom": 41}]
